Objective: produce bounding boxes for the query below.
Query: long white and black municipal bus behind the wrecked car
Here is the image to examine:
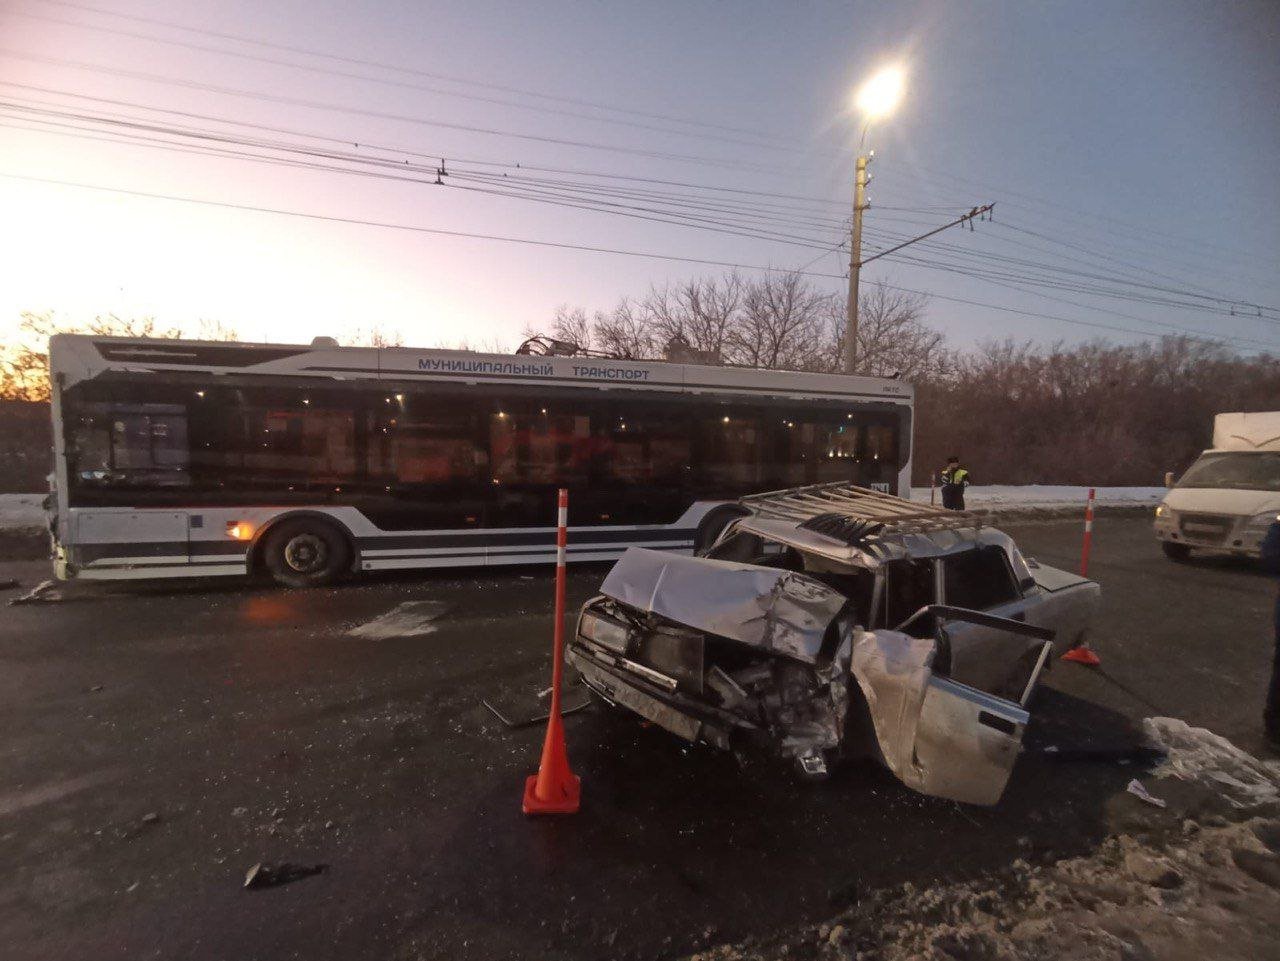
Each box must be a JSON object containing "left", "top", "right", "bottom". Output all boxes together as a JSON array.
[{"left": 50, "top": 335, "right": 914, "bottom": 586}]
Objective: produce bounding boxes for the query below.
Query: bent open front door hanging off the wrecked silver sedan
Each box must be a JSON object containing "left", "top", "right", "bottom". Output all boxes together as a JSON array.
[{"left": 850, "top": 604, "right": 1053, "bottom": 805}]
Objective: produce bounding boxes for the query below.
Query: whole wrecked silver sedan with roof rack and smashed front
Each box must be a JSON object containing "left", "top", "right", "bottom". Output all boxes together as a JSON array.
[{"left": 568, "top": 484, "right": 1100, "bottom": 805}]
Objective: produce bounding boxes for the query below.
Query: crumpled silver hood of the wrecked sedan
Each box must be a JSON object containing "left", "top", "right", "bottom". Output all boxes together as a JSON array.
[{"left": 600, "top": 548, "right": 847, "bottom": 663}]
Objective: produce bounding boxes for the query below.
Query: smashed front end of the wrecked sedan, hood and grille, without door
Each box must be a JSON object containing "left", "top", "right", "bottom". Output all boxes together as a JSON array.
[{"left": 568, "top": 549, "right": 847, "bottom": 774}]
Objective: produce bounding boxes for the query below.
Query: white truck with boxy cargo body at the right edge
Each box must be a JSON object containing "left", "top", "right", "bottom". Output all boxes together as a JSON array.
[{"left": 1156, "top": 411, "right": 1280, "bottom": 560}]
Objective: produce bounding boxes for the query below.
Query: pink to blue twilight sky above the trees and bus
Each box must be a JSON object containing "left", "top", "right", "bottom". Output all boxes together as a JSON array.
[{"left": 0, "top": 0, "right": 1280, "bottom": 353}]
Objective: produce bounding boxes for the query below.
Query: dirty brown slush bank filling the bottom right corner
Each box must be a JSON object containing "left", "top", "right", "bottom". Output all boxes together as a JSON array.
[{"left": 686, "top": 820, "right": 1280, "bottom": 961}]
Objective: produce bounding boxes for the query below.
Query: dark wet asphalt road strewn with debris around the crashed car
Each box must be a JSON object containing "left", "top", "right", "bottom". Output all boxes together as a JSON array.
[{"left": 0, "top": 514, "right": 1274, "bottom": 961}]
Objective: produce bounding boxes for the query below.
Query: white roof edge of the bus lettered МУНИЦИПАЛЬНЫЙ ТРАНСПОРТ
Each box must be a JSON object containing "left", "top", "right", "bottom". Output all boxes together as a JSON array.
[{"left": 49, "top": 334, "right": 914, "bottom": 404}]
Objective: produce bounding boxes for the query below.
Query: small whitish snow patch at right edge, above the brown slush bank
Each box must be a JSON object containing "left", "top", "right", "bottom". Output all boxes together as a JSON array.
[{"left": 1142, "top": 718, "right": 1280, "bottom": 807}]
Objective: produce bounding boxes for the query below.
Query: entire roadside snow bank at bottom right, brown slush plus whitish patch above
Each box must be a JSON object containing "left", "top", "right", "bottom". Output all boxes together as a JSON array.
[{"left": 686, "top": 718, "right": 1280, "bottom": 961}]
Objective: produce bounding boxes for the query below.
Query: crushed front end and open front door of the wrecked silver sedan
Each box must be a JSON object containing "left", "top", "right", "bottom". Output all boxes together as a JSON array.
[{"left": 568, "top": 548, "right": 1052, "bottom": 805}]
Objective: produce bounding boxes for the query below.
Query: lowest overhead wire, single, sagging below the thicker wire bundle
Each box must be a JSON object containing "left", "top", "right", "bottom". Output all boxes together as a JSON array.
[{"left": 0, "top": 173, "right": 1280, "bottom": 349}]
